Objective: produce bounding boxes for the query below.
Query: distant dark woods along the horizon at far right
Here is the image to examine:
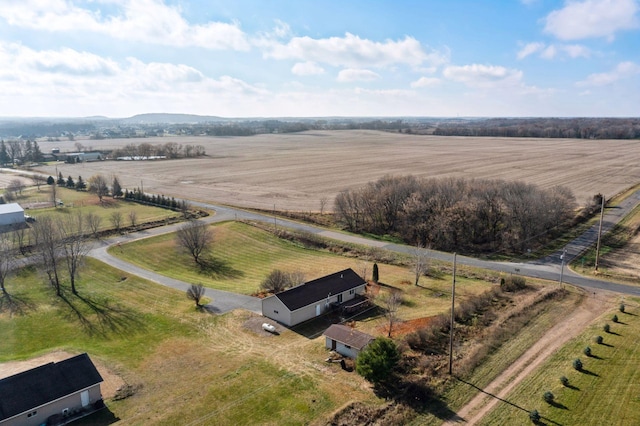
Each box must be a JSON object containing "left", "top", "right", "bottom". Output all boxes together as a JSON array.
[{"left": 434, "top": 118, "right": 640, "bottom": 139}]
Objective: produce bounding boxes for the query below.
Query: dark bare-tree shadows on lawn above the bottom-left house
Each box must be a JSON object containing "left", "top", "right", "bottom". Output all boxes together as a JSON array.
[{"left": 60, "top": 293, "right": 145, "bottom": 336}]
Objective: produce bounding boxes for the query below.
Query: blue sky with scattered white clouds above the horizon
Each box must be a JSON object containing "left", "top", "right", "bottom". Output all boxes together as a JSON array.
[{"left": 0, "top": 0, "right": 640, "bottom": 118}]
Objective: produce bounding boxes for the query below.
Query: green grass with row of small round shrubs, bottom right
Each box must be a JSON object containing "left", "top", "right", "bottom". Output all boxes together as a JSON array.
[{"left": 482, "top": 300, "right": 640, "bottom": 426}]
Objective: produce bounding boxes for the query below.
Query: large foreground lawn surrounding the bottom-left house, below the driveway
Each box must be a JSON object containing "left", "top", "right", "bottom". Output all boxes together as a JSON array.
[{"left": 0, "top": 260, "right": 375, "bottom": 425}]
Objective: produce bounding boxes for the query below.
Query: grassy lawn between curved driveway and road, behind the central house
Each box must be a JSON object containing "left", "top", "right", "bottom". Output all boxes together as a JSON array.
[{"left": 109, "top": 222, "right": 489, "bottom": 302}]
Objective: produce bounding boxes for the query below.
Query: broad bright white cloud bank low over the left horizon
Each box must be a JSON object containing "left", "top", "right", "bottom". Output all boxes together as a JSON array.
[{"left": 0, "top": 42, "right": 270, "bottom": 116}]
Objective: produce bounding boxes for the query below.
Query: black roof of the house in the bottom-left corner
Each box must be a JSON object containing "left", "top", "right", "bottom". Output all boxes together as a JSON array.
[{"left": 0, "top": 353, "right": 102, "bottom": 421}]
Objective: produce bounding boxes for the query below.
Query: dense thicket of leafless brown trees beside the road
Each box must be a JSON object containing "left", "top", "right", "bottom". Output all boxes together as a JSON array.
[{"left": 334, "top": 176, "right": 580, "bottom": 252}]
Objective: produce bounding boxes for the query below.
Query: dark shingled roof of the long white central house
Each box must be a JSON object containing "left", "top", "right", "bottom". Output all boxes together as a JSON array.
[{"left": 276, "top": 268, "right": 366, "bottom": 311}]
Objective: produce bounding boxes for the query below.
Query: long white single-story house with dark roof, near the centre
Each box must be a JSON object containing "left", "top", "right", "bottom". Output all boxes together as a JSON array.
[{"left": 262, "top": 268, "right": 367, "bottom": 327}]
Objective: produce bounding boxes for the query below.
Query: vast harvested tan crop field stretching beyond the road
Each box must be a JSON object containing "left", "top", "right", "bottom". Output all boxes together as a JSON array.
[{"left": 27, "top": 130, "right": 640, "bottom": 211}]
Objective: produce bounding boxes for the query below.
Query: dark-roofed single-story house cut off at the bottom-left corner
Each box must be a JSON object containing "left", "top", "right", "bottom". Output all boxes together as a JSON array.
[{"left": 0, "top": 353, "right": 104, "bottom": 426}]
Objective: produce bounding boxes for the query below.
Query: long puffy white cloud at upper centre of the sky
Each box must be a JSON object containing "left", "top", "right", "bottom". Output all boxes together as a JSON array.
[{"left": 263, "top": 33, "right": 447, "bottom": 68}]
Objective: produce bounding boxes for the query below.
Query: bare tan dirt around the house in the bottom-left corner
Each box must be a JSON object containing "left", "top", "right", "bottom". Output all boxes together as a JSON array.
[{"left": 0, "top": 351, "right": 125, "bottom": 399}]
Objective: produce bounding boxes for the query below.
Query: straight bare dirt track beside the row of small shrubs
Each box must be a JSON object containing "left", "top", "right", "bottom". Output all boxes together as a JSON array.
[{"left": 443, "top": 292, "right": 610, "bottom": 426}]
